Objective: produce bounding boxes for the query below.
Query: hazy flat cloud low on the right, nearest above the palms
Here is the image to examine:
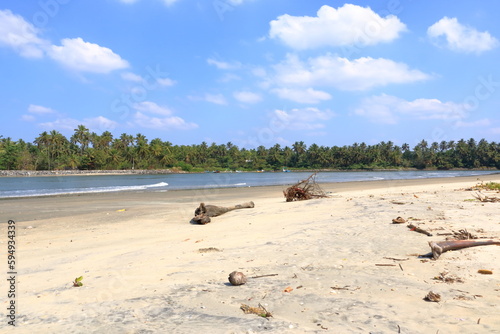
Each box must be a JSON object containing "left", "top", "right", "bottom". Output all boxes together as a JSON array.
[{"left": 354, "top": 94, "right": 467, "bottom": 124}]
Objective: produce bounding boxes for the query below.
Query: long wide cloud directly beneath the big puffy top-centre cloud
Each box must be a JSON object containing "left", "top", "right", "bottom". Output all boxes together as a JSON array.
[{"left": 273, "top": 54, "right": 430, "bottom": 91}]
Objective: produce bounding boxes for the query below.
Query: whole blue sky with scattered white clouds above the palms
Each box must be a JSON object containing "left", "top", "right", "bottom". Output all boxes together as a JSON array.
[{"left": 0, "top": 0, "right": 500, "bottom": 148}]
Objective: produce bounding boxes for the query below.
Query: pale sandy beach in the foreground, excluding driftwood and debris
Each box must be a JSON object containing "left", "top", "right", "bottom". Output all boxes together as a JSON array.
[{"left": 0, "top": 174, "right": 500, "bottom": 334}]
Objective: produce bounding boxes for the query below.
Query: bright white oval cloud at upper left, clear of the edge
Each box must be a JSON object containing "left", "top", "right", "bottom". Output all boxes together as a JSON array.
[{"left": 49, "top": 37, "right": 129, "bottom": 73}]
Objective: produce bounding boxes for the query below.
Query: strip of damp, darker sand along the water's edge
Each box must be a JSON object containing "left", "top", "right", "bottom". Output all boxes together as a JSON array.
[{"left": 0, "top": 174, "right": 500, "bottom": 221}]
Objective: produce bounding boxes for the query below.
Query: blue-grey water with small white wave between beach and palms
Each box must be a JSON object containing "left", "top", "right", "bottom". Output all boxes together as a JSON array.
[{"left": 0, "top": 171, "right": 498, "bottom": 198}]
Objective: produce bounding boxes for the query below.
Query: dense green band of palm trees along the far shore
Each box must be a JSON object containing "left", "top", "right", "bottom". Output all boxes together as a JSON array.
[{"left": 0, "top": 125, "right": 500, "bottom": 171}]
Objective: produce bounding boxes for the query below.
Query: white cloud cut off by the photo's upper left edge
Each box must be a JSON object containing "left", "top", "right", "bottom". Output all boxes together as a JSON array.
[{"left": 0, "top": 10, "right": 48, "bottom": 58}]
